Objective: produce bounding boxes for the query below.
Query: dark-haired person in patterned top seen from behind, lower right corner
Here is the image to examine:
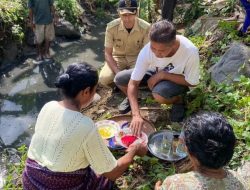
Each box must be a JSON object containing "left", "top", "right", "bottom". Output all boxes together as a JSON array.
[{"left": 155, "top": 112, "right": 250, "bottom": 190}]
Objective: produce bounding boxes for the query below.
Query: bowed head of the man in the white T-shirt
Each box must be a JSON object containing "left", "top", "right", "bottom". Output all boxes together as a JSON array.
[{"left": 149, "top": 20, "right": 176, "bottom": 58}]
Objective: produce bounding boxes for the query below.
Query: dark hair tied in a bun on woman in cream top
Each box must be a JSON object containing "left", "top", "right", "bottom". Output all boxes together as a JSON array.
[{"left": 55, "top": 62, "right": 98, "bottom": 98}]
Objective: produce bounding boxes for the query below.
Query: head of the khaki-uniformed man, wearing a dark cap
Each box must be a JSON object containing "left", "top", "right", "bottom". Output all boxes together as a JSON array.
[{"left": 118, "top": 0, "right": 137, "bottom": 29}]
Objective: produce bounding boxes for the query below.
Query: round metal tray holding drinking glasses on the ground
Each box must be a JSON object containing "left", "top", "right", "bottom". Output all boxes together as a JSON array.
[{"left": 148, "top": 130, "right": 187, "bottom": 162}]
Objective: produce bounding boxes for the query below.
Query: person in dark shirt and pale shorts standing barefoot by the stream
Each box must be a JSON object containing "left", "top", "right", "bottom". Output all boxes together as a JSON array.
[{"left": 28, "top": 0, "right": 55, "bottom": 61}]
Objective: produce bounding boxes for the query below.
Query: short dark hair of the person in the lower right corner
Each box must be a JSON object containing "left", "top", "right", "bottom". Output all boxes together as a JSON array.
[{"left": 184, "top": 112, "right": 236, "bottom": 169}]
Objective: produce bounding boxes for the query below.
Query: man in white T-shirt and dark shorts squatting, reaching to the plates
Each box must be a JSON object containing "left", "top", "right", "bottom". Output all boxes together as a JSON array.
[{"left": 114, "top": 20, "right": 199, "bottom": 135}]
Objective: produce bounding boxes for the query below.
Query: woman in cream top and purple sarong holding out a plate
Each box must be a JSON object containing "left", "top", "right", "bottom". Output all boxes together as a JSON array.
[{"left": 22, "top": 63, "right": 147, "bottom": 190}]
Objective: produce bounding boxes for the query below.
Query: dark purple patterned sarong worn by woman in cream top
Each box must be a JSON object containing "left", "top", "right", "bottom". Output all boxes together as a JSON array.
[{"left": 22, "top": 158, "right": 114, "bottom": 190}]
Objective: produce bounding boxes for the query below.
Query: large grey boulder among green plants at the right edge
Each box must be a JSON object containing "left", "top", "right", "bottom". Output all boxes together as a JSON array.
[{"left": 209, "top": 43, "right": 250, "bottom": 83}]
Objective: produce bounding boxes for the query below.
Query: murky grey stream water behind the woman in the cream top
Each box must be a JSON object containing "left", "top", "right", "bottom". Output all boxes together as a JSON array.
[{"left": 0, "top": 23, "right": 105, "bottom": 189}]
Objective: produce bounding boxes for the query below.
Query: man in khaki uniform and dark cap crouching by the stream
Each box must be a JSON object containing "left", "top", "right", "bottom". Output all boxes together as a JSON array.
[{"left": 99, "top": 0, "right": 150, "bottom": 86}]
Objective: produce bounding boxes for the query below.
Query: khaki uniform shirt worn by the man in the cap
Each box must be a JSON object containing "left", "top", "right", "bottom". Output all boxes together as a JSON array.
[{"left": 104, "top": 17, "right": 150, "bottom": 66}]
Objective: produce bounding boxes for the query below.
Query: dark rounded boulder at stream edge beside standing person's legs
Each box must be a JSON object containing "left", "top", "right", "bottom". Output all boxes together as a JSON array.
[{"left": 55, "top": 21, "right": 81, "bottom": 39}]
